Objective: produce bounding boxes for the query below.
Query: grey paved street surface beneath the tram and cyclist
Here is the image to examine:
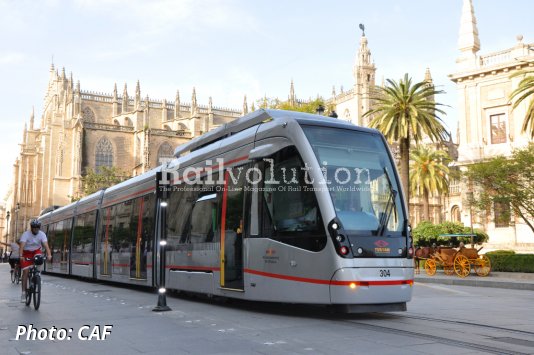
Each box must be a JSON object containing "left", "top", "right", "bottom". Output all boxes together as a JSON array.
[{"left": 0, "top": 264, "right": 534, "bottom": 355}]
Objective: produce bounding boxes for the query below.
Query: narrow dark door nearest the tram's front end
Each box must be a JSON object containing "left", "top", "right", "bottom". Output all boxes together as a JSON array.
[{"left": 220, "top": 167, "right": 246, "bottom": 290}]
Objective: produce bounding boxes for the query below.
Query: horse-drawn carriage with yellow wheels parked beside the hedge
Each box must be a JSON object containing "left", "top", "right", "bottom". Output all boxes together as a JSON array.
[{"left": 415, "top": 234, "right": 491, "bottom": 277}]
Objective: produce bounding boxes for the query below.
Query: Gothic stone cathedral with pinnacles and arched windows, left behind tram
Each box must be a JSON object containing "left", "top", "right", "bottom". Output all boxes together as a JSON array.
[{"left": 4, "top": 65, "right": 243, "bottom": 242}]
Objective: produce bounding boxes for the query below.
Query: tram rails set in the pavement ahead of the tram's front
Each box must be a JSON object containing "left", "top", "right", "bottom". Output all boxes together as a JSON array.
[{"left": 345, "top": 313, "right": 534, "bottom": 355}]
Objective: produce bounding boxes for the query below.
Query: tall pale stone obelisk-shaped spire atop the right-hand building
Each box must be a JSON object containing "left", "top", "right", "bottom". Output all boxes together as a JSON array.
[{"left": 456, "top": 0, "right": 480, "bottom": 67}]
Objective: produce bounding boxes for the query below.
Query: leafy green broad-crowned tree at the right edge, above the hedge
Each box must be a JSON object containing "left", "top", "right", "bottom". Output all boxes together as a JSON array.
[{"left": 466, "top": 143, "right": 534, "bottom": 232}]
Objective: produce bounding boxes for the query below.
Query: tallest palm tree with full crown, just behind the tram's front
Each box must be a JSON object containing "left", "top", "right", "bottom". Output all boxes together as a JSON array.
[{"left": 364, "top": 74, "right": 449, "bottom": 211}]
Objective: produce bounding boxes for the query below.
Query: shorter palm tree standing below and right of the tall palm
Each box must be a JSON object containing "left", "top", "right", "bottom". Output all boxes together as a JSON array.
[{"left": 410, "top": 145, "right": 451, "bottom": 221}]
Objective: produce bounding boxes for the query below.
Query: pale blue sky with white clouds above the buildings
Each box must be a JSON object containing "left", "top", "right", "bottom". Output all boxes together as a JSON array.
[{"left": 0, "top": 0, "right": 534, "bottom": 199}]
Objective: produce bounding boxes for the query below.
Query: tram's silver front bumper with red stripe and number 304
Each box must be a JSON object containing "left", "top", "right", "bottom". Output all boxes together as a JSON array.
[{"left": 330, "top": 267, "right": 413, "bottom": 305}]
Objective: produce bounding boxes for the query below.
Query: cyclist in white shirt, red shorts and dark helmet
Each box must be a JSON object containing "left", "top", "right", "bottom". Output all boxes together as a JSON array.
[{"left": 20, "top": 219, "right": 52, "bottom": 302}]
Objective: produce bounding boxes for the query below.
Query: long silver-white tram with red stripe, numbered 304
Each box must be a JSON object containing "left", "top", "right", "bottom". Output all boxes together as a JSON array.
[{"left": 40, "top": 110, "right": 414, "bottom": 312}]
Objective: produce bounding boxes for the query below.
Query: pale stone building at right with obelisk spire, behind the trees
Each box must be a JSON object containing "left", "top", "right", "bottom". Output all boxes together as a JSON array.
[{"left": 447, "top": 0, "right": 534, "bottom": 251}]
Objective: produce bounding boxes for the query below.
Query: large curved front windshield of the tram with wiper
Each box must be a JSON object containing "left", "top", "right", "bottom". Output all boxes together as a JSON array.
[{"left": 303, "top": 126, "right": 405, "bottom": 235}]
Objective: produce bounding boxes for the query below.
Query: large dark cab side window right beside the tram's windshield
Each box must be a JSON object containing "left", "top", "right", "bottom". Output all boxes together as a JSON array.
[{"left": 261, "top": 147, "right": 326, "bottom": 251}]
